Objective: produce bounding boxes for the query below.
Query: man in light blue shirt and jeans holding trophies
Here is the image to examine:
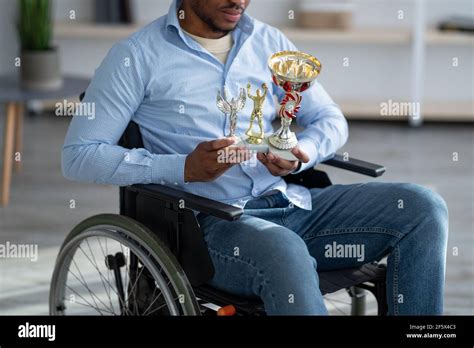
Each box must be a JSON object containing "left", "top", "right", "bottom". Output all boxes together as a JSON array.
[{"left": 62, "top": 0, "right": 448, "bottom": 315}]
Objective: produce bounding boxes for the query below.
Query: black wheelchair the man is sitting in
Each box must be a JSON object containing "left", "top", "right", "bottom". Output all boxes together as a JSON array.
[{"left": 49, "top": 95, "right": 387, "bottom": 316}]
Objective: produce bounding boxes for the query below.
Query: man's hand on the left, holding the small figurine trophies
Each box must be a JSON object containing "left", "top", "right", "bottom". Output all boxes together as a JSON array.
[{"left": 184, "top": 138, "right": 251, "bottom": 182}]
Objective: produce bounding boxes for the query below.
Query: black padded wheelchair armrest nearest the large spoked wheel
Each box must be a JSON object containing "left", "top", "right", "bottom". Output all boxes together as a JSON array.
[{"left": 127, "top": 184, "right": 244, "bottom": 221}]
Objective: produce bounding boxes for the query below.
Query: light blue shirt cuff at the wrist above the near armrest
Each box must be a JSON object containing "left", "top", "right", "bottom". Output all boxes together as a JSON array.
[{"left": 151, "top": 154, "right": 187, "bottom": 186}]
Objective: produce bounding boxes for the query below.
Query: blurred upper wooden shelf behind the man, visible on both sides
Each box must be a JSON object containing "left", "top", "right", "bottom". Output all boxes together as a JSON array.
[{"left": 54, "top": 22, "right": 474, "bottom": 45}]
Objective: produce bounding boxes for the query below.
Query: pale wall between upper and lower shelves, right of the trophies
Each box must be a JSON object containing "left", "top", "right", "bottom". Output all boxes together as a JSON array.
[{"left": 297, "top": 42, "right": 474, "bottom": 102}]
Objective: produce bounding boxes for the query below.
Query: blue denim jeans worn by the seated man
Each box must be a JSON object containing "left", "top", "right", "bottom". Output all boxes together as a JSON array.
[{"left": 198, "top": 183, "right": 448, "bottom": 315}]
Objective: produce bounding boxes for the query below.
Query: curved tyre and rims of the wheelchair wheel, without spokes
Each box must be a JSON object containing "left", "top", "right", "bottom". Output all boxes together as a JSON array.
[{"left": 49, "top": 214, "right": 200, "bottom": 315}]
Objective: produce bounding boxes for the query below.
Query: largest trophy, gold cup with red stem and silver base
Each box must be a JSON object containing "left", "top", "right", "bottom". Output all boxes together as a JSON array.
[{"left": 268, "top": 51, "right": 321, "bottom": 157}]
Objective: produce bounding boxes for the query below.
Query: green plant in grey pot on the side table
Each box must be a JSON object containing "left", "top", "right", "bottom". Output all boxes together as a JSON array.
[{"left": 18, "top": 0, "right": 62, "bottom": 91}]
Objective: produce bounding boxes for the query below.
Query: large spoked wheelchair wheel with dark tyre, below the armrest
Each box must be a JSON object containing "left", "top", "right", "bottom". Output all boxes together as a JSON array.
[{"left": 49, "top": 214, "right": 200, "bottom": 315}]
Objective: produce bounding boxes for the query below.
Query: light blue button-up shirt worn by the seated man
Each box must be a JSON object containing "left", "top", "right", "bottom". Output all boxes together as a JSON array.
[{"left": 62, "top": 1, "right": 348, "bottom": 209}]
